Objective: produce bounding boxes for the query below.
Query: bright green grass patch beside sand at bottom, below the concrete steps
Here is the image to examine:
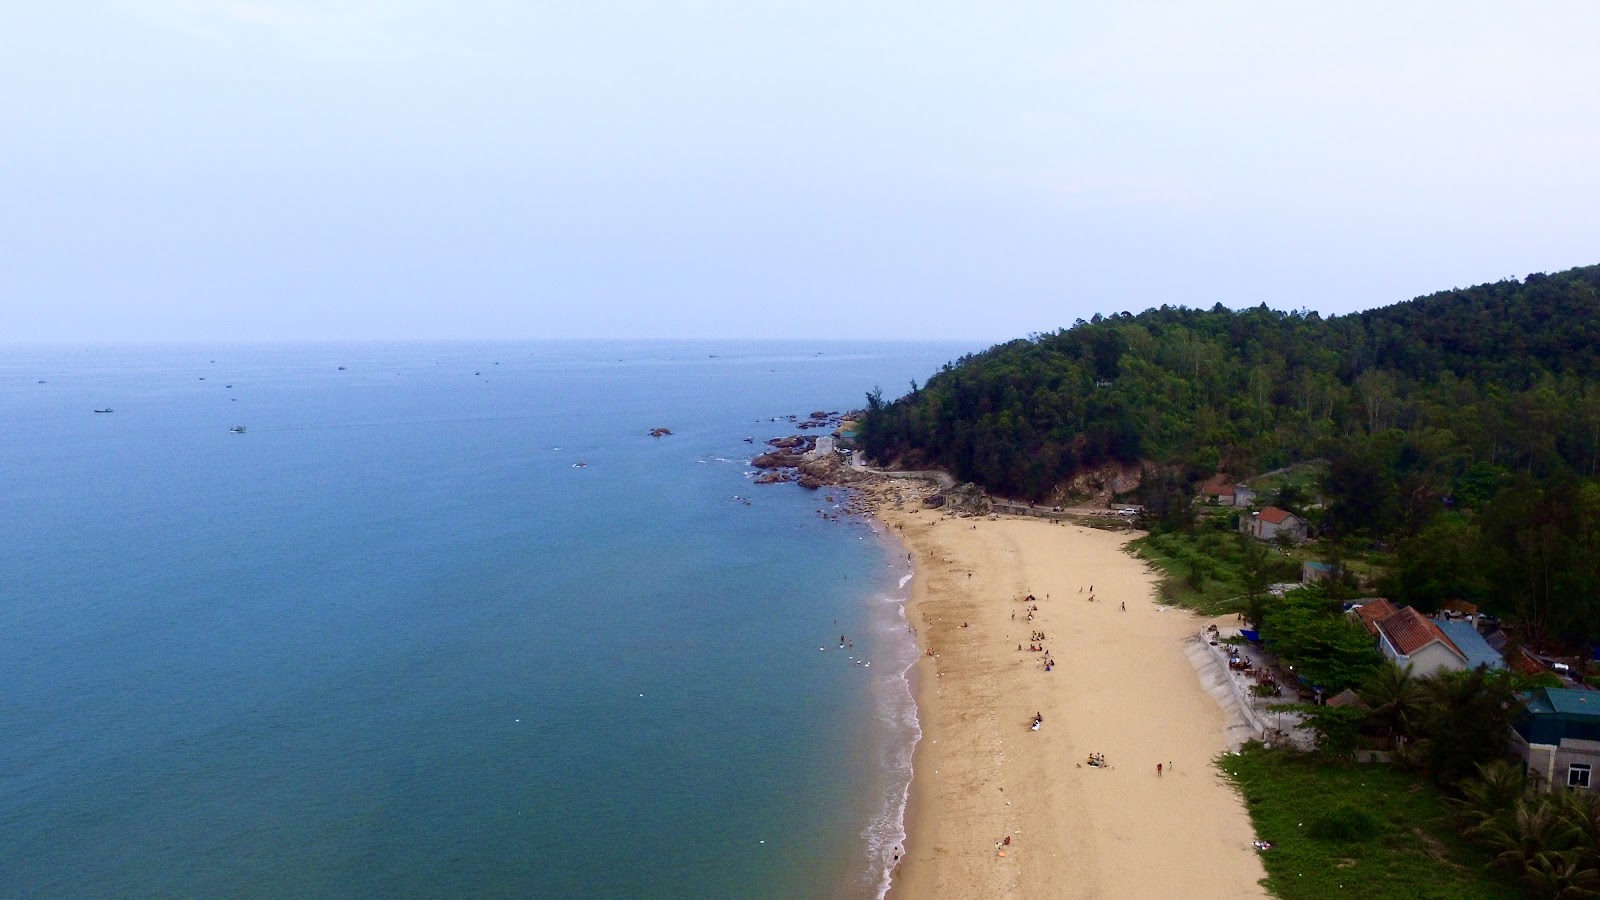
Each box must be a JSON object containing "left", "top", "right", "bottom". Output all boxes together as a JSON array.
[{"left": 1218, "top": 743, "right": 1523, "bottom": 900}]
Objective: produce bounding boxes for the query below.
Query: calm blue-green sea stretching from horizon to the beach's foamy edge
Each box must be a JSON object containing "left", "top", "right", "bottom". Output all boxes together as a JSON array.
[{"left": 0, "top": 343, "right": 976, "bottom": 897}]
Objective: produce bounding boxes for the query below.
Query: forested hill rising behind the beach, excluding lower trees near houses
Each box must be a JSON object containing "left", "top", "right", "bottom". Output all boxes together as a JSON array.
[{"left": 861, "top": 259, "right": 1600, "bottom": 499}]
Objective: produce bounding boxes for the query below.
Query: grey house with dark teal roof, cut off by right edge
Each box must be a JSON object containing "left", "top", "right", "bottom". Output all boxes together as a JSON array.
[{"left": 1510, "top": 687, "right": 1600, "bottom": 791}]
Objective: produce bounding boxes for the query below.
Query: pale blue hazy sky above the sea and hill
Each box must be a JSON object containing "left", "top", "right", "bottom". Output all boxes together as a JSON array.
[{"left": 0, "top": 0, "right": 1600, "bottom": 343}]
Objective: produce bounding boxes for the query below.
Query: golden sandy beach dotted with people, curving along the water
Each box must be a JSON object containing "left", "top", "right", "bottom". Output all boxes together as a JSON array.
[{"left": 872, "top": 485, "right": 1266, "bottom": 900}]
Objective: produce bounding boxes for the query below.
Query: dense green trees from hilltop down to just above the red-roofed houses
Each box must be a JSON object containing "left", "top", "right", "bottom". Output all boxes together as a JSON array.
[{"left": 861, "top": 266, "right": 1600, "bottom": 642}]
